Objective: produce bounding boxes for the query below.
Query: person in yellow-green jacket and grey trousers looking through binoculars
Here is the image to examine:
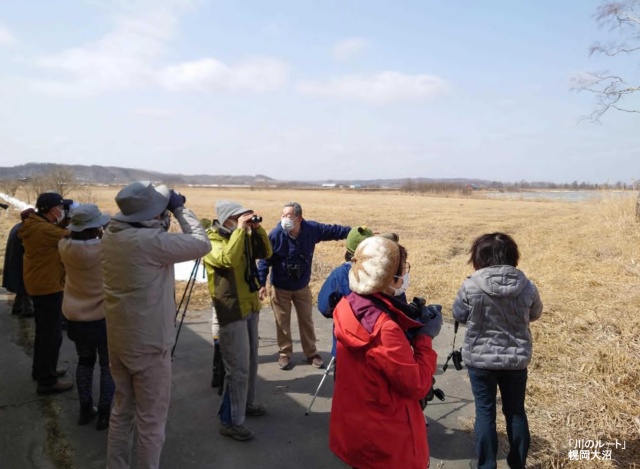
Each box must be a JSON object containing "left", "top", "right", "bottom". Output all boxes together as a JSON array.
[{"left": 204, "top": 200, "right": 272, "bottom": 441}]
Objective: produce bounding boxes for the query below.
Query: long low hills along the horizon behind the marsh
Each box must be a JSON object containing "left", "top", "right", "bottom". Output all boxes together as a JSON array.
[{"left": 0, "top": 163, "right": 491, "bottom": 188}]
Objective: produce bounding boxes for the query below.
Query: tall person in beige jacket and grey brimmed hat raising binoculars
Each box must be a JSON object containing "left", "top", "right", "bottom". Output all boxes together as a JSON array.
[{"left": 102, "top": 181, "right": 211, "bottom": 469}]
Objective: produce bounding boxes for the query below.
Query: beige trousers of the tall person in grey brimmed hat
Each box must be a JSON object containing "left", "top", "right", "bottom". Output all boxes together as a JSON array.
[{"left": 107, "top": 350, "right": 171, "bottom": 469}]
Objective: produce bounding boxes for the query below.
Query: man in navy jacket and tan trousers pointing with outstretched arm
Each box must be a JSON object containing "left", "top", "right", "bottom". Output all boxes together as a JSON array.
[{"left": 258, "top": 202, "right": 351, "bottom": 370}]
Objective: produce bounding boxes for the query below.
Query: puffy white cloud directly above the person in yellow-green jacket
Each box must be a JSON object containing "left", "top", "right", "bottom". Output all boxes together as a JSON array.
[{"left": 159, "top": 58, "right": 288, "bottom": 92}]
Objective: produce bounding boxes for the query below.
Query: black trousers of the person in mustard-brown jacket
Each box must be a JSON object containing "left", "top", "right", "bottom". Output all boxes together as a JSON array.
[{"left": 31, "top": 292, "right": 63, "bottom": 386}]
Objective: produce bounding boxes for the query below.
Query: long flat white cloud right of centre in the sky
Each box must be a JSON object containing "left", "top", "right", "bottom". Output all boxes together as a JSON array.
[{"left": 298, "top": 71, "right": 448, "bottom": 104}]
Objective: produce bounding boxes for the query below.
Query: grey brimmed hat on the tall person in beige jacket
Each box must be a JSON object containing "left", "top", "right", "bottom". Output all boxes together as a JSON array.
[{"left": 113, "top": 181, "right": 170, "bottom": 223}]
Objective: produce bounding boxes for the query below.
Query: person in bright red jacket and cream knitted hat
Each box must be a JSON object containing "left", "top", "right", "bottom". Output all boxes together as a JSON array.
[{"left": 329, "top": 236, "right": 442, "bottom": 469}]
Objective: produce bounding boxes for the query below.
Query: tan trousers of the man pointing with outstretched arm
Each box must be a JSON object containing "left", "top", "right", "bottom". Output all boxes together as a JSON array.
[{"left": 269, "top": 285, "right": 317, "bottom": 357}]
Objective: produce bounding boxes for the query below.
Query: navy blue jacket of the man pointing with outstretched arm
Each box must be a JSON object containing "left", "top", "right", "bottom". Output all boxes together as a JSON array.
[{"left": 258, "top": 219, "right": 351, "bottom": 291}]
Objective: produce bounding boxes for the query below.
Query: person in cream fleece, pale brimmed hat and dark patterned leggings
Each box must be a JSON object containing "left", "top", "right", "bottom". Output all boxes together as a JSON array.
[{"left": 58, "top": 204, "right": 114, "bottom": 430}]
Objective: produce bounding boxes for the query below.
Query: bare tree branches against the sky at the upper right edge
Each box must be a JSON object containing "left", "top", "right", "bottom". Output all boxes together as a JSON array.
[{"left": 573, "top": 0, "right": 640, "bottom": 122}]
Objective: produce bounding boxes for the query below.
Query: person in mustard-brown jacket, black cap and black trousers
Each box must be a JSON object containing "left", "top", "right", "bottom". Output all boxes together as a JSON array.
[{"left": 18, "top": 192, "right": 73, "bottom": 394}]
